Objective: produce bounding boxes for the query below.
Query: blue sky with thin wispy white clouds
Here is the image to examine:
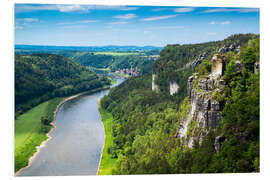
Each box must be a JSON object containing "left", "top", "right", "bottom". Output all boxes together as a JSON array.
[{"left": 14, "top": 4, "right": 260, "bottom": 46}]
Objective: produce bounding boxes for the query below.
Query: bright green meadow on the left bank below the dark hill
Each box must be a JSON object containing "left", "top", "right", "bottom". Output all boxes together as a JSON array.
[{"left": 15, "top": 98, "right": 63, "bottom": 172}]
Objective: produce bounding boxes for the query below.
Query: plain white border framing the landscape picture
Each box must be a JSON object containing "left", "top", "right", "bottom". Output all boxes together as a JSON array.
[{"left": 0, "top": 0, "right": 270, "bottom": 180}]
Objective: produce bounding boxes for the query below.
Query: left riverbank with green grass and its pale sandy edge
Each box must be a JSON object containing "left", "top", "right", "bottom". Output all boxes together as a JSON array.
[{"left": 15, "top": 86, "right": 109, "bottom": 175}]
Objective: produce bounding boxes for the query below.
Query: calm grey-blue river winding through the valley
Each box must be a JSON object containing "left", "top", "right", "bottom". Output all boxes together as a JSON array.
[{"left": 18, "top": 79, "right": 124, "bottom": 176}]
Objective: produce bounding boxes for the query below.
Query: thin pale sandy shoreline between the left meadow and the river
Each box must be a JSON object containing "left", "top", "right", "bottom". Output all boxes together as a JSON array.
[{"left": 15, "top": 87, "right": 109, "bottom": 176}]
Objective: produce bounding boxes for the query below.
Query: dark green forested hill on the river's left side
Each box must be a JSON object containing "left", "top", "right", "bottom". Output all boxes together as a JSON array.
[{"left": 15, "top": 53, "right": 110, "bottom": 116}]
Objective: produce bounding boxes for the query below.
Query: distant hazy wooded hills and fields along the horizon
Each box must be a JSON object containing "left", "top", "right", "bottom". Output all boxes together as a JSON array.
[{"left": 15, "top": 46, "right": 160, "bottom": 74}]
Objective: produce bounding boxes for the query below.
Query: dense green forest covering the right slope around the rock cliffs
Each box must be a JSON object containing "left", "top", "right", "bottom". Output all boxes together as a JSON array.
[{"left": 101, "top": 34, "right": 260, "bottom": 174}]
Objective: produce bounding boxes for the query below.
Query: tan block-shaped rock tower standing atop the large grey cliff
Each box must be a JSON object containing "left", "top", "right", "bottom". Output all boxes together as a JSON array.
[{"left": 211, "top": 54, "right": 225, "bottom": 77}]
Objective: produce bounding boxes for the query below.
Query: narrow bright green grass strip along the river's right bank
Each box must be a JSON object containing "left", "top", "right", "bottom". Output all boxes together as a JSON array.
[{"left": 98, "top": 104, "right": 116, "bottom": 175}]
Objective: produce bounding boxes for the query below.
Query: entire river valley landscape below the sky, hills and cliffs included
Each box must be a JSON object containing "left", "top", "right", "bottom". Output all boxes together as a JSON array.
[{"left": 15, "top": 34, "right": 260, "bottom": 176}]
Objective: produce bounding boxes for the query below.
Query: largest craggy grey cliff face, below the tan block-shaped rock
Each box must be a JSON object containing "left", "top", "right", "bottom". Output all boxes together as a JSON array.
[{"left": 177, "top": 71, "right": 225, "bottom": 147}]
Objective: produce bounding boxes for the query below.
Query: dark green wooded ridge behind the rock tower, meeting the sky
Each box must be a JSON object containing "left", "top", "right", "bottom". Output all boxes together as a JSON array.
[{"left": 153, "top": 34, "right": 258, "bottom": 100}]
